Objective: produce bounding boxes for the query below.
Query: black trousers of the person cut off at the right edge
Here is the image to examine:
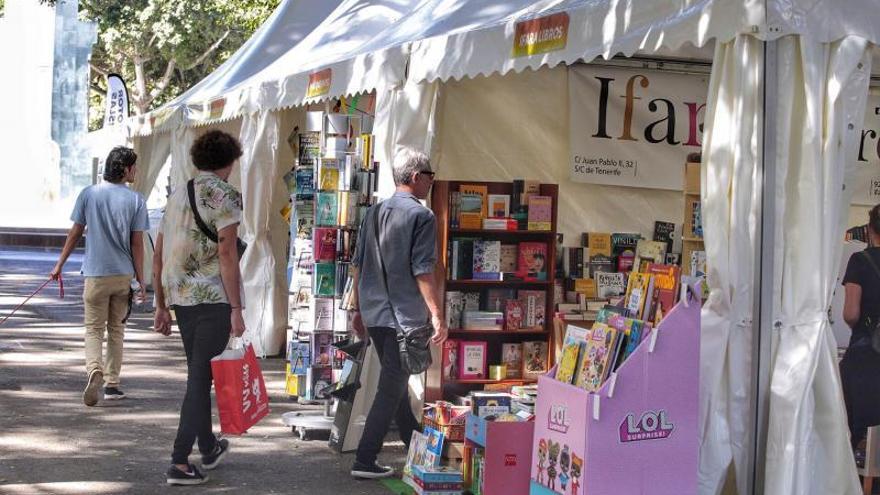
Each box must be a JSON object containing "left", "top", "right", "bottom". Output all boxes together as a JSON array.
[{"left": 840, "top": 341, "right": 880, "bottom": 448}]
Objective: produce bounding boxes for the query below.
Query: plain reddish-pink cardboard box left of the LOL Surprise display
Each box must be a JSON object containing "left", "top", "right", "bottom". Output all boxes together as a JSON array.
[{"left": 465, "top": 414, "right": 535, "bottom": 495}]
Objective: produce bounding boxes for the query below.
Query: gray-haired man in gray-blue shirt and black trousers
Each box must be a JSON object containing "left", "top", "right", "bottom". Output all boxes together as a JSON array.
[{"left": 351, "top": 150, "right": 448, "bottom": 478}]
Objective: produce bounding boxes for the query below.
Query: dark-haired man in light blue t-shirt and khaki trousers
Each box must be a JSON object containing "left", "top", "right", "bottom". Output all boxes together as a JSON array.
[{"left": 49, "top": 146, "right": 150, "bottom": 406}]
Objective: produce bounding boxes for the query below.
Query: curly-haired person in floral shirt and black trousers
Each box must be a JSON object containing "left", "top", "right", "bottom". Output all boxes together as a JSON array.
[{"left": 153, "top": 131, "right": 245, "bottom": 485}]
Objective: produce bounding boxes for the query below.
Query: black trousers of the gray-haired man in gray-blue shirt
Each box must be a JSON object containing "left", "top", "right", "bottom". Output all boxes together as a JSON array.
[{"left": 357, "top": 327, "right": 419, "bottom": 464}]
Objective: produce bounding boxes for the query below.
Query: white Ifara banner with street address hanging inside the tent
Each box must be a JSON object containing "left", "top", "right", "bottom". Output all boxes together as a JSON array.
[{"left": 568, "top": 66, "right": 709, "bottom": 190}]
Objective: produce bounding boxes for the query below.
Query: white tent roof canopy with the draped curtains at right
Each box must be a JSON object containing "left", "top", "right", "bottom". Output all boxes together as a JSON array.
[{"left": 131, "top": 0, "right": 880, "bottom": 495}]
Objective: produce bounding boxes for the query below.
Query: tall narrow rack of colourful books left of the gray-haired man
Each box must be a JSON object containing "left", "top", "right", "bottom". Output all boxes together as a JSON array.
[{"left": 288, "top": 112, "right": 378, "bottom": 401}]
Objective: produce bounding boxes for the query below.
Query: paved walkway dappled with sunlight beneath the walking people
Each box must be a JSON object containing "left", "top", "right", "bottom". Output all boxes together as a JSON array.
[{"left": 0, "top": 249, "right": 405, "bottom": 495}]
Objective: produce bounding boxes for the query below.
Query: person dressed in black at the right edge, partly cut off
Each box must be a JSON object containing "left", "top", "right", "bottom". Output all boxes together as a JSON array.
[{"left": 840, "top": 205, "right": 880, "bottom": 462}]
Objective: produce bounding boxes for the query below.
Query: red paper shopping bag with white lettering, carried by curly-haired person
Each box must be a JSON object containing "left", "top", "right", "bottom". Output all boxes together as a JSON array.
[{"left": 211, "top": 344, "right": 269, "bottom": 435}]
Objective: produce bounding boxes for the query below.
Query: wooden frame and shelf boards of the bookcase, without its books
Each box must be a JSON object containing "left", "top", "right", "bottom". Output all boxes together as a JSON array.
[{"left": 425, "top": 180, "right": 559, "bottom": 402}]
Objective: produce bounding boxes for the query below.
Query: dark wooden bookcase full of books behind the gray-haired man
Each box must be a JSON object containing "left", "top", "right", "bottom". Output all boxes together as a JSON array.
[{"left": 426, "top": 180, "right": 559, "bottom": 402}]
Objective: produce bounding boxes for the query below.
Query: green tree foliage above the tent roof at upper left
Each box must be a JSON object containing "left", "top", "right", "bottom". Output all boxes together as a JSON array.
[{"left": 42, "top": 0, "right": 279, "bottom": 128}]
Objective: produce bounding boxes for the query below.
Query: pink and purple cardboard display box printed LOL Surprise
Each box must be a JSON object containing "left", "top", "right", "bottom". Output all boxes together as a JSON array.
[{"left": 528, "top": 299, "right": 700, "bottom": 495}]
